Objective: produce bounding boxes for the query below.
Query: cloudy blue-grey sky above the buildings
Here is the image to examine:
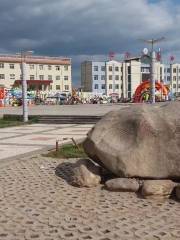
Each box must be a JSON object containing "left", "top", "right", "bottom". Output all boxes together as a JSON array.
[{"left": 0, "top": 0, "right": 180, "bottom": 86}]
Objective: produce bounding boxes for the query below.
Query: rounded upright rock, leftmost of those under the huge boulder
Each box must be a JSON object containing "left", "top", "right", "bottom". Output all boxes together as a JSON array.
[{"left": 71, "top": 159, "right": 101, "bottom": 187}]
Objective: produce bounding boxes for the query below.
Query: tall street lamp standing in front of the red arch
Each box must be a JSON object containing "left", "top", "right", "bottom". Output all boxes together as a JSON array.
[{"left": 141, "top": 37, "right": 165, "bottom": 103}]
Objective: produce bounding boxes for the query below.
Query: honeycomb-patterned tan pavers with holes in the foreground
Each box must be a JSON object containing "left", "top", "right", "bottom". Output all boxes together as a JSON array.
[{"left": 0, "top": 155, "right": 180, "bottom": 240}]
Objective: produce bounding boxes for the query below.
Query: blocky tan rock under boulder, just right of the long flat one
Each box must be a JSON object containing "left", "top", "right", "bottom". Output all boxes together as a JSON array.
[{"left": 142, "top": 180, "right": 176, "bottom": 198}]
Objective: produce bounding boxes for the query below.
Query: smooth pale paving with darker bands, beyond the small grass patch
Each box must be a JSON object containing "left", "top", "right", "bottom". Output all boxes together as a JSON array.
[{"left": 0, "top": 124, "right": 92, "bottom": 161}]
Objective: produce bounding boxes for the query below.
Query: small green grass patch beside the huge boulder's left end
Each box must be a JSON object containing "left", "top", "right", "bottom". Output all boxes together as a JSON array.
[{"left": 43, "top": 144, "right": 87, "bottom": 158}]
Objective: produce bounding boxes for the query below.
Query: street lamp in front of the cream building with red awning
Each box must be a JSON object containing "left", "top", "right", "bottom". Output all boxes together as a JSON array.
[{"left": 16, "top": 51, "right": 34, "bottom": 122}]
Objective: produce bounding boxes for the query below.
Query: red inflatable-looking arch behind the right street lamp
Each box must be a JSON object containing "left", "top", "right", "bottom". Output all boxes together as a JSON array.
[{"left": 134, "top": 81, "right": 169, "bottom": 103}]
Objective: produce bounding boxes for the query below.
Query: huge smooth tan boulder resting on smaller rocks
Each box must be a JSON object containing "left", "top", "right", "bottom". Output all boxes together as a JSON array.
[{"left": 84, "top": 102, "right": 180, "bottom": 179}]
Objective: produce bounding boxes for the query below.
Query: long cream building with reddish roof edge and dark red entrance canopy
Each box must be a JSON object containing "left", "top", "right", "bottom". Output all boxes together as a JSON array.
[{"left": 0, "top": 55, "right": 72, "bottom": 92}]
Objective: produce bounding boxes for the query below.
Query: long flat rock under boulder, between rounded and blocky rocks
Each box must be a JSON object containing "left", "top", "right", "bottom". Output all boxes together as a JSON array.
[{"left": 105, "top": 178, "right": 139, "bottom": 192}]
